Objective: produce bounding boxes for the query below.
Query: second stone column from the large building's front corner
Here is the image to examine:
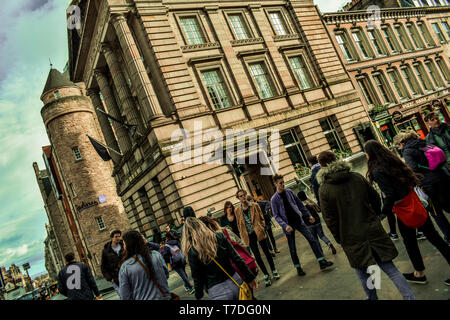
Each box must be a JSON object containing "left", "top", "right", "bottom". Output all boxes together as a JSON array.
[{"left": 102, "top": 44, "right": 145, "bottom": 134}]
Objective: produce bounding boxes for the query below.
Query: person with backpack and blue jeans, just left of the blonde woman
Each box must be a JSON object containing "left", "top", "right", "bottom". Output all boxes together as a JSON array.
[{"left": 162, "top": 232, "right": 195, "bottom": 294}]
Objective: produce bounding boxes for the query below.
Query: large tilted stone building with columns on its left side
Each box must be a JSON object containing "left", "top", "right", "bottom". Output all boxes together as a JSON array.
[{"left": 69, "top": 0, "right": 375, "bottom": 236}]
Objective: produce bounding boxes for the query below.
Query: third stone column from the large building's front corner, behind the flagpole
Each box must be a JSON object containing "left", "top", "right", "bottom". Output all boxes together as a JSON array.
[{"left": 95, "top": 70, "right": 131, "bottom": 154}]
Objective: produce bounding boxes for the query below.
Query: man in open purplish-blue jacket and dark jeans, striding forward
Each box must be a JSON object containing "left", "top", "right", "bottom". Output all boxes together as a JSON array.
[{"left": 270, "top": 174, "right": 333, "bottom": 276}]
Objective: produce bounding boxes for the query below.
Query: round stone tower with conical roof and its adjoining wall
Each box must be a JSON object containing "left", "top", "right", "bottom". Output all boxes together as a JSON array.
[{"left": 33, "top": 69, "right": 130, "bottom": 276}]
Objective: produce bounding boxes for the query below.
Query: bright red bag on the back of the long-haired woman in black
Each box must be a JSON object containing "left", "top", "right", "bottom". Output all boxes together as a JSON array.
[{"left": 392, "top": 189, "right": 428, "bottom": 229}]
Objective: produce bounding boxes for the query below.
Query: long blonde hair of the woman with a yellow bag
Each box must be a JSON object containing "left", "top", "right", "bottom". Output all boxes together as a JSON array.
[{"left": 181, "top": 217, "right": 218, "bottom": 264}]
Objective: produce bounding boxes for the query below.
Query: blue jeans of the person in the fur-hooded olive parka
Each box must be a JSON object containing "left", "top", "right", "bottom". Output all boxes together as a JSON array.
[{"left": 355, "top": 258, "right": 416, "bottom": 300}]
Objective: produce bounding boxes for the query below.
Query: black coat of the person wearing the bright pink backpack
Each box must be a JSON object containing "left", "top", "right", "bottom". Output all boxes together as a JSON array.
[{"left": 402, "top": 139, "right": 447, "bottom": 190}]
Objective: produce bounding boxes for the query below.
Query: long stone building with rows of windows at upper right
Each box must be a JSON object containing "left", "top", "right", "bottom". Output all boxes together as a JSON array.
[{"left": 323, "top": 6, "right": 450, "bottom": 144}]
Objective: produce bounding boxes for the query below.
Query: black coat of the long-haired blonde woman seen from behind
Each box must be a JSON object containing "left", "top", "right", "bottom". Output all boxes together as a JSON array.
[{"left": 188, "top": 232, "right": 256, "bottom": 299}]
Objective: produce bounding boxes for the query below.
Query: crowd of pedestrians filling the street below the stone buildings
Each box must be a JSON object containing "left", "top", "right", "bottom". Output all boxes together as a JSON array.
[{"left": 58, "top": 112, "right": 450, "bottom": 300}]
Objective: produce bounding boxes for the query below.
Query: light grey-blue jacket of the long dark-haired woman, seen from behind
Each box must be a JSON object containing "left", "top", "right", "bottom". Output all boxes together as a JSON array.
[{"left": 119, "top": 251, "right": 170, "bottom": 300}]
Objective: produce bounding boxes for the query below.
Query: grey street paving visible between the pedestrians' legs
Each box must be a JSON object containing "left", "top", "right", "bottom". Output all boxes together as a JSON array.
[{"left": 103, "top": 219, "right": 450, "bottom": 300}]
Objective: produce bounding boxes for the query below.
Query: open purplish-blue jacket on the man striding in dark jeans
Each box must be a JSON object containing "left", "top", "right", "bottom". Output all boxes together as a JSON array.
[{"left": 270, "top": 189, "right": 311, "bottom": 234}]
